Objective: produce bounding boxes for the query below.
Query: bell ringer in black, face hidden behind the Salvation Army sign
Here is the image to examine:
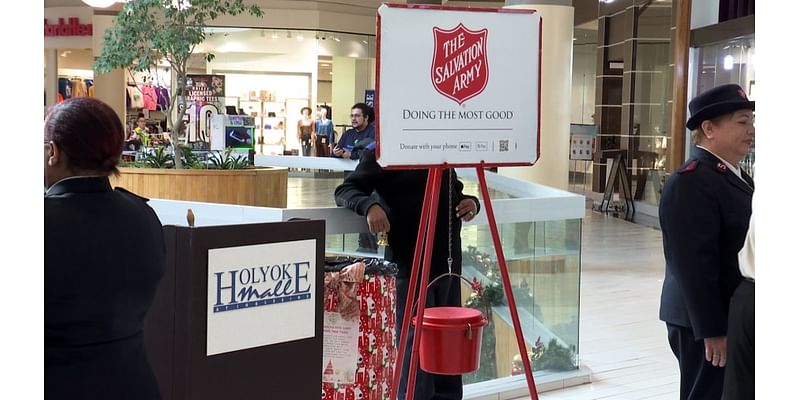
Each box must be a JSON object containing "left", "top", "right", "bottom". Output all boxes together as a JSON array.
[{"left": 335, "top": 150, "right": 480, "bottom": 400}]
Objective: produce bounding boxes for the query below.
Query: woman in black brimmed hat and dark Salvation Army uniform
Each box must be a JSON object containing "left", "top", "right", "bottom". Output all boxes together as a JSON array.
[{"left": 659, "top": 84, "right": 755, "bottom": 399}]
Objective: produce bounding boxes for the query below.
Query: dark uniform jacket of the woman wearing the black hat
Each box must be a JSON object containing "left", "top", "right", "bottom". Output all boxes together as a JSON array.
[{"left": 659, "top": 147, "right": 754, "bottom": 340}]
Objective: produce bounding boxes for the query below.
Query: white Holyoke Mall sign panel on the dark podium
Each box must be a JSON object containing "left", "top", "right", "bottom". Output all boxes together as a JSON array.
[{"left": 206, "top": 239, "right": 317, "bottom": 356}]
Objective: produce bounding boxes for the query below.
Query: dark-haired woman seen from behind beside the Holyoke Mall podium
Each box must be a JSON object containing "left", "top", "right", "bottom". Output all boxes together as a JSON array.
[{"left": 44, "top": 97, "right": 166, "bottom": 400}]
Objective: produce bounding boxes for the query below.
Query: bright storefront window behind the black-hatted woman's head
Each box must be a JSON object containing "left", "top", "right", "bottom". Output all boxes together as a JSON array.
[{"left": 689, "top": 35, "right": 756, "bottom": 175}]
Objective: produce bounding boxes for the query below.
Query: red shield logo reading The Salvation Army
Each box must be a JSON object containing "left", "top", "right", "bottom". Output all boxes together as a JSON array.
[{"left": 431, "top": 24, "right": 489, "bottom": 105}]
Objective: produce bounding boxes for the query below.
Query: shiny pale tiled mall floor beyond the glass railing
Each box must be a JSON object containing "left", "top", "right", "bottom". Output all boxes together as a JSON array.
[{"left": 288, "top": 178, "right": 679, "bottom": 400}]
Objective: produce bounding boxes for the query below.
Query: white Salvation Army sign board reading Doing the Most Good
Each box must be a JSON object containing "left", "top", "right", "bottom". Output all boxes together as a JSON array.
[{"left": 376, "top": 4, "right": 541, "bottom": 167}]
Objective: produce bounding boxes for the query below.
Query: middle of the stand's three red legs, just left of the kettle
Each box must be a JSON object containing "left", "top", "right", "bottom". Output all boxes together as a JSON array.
[{"left": 401, "top": 167, "right": 443, "bottom": 400}]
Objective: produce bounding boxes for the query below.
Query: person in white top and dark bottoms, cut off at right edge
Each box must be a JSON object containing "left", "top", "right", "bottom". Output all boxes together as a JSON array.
[{"left": 723, "top": 188, "right": 756, "bottom": 400}]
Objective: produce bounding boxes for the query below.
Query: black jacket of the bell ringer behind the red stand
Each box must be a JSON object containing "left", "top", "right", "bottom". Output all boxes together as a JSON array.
[{"left": 335, "top": 151, "right": 480, "bottom": 278}]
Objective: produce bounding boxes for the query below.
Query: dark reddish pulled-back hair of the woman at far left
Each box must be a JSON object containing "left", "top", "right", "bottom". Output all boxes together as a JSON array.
[{"left": 44, "top": 97, "right": 125, "bottom": 175}]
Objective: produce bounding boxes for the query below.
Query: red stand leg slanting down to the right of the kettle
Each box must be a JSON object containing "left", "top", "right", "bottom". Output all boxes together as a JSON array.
[{"left": 475, "top": 163, "right": 539, "bottom": 400}]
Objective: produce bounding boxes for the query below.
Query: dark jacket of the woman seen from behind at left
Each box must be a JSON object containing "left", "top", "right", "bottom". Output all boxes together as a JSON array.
[{"left": 44, "top": 177, "right": 166, "bottom": 399}]
